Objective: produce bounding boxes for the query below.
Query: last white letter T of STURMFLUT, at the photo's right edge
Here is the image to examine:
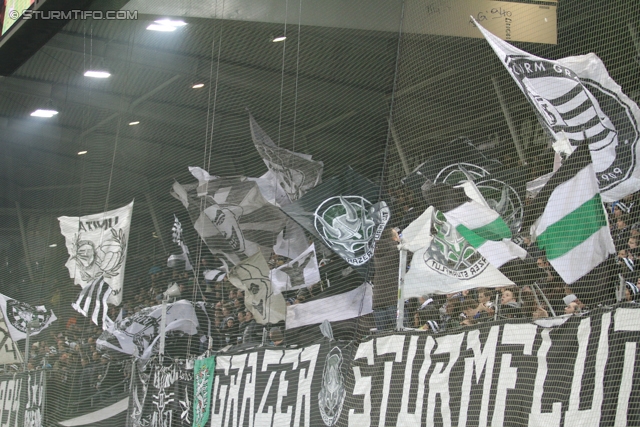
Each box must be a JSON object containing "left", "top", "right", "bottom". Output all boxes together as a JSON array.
[{"left": 613, "top": 308, "right": 640, "bottom": 427}]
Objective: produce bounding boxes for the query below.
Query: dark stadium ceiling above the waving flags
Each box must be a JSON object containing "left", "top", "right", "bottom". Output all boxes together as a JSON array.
[{"left": 0, "top": 0, "right": 640, "bottom": 258}]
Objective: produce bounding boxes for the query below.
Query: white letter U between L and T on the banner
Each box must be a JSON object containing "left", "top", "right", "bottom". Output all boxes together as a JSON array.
[{"left": 564, "top": 313, "right": 611, "bottom": 427}]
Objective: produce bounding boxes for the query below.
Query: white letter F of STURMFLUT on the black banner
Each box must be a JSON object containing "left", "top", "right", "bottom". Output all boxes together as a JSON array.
[{"left": 491, "top": 323, "right": 538, "bottom": 427}]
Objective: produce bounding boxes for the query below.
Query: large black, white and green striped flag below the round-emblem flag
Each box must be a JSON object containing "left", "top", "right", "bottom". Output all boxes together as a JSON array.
[{"left": 531, "top": 144, "right": 615, "bottom": 284}]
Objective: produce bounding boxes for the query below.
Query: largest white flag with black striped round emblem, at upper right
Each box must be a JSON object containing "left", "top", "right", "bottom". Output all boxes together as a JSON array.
[{"left": 476, "top": 22, "right": 640, "bottom": 202}]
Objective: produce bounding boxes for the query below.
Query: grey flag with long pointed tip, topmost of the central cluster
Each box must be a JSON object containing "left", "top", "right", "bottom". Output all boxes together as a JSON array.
[{"left": 249, "top": 115, "right": 324, "bottom": 201}]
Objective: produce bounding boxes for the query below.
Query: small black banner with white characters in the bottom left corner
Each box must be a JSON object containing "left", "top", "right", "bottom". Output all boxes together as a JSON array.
[{"left": 0, "top": 371, "right": 44, "bottom": 427}]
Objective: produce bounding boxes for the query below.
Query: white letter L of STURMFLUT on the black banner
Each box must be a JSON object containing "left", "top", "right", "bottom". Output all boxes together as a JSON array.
[{"left": 529, "top": 329, "right": 562, "bottom": 427}]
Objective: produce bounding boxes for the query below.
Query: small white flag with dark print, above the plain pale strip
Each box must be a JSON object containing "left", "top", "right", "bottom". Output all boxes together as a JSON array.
[{"left": 270, "top": 243, "right": 320, "bottom": 294}]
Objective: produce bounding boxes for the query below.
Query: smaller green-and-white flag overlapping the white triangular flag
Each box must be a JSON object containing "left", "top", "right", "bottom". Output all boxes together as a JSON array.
[{"left": 444, "top": 181, "right": 527, "bottom": 268}]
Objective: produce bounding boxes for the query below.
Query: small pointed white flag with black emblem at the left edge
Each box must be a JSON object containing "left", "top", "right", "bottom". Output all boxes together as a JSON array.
[{"left": 0, "top": 294, "right": 57, "bottom": 341}]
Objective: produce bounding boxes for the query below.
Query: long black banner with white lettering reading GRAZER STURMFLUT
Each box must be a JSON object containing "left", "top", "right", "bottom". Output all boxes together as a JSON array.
[{"left": 188, "top": 305, "right": 640, "bottom": 427}]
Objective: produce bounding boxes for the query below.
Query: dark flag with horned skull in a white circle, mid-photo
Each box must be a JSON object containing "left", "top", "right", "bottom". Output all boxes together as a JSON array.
[{"left": 282, "top": 168, "right": 391, "bottom": 267}]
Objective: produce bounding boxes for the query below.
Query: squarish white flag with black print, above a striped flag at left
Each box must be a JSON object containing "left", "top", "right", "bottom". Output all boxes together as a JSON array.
[{"left": 58, "top": 202, "right": 133, "bottom": 305}]
